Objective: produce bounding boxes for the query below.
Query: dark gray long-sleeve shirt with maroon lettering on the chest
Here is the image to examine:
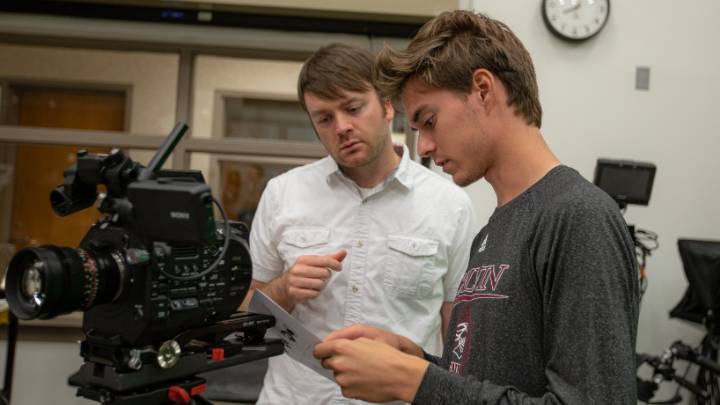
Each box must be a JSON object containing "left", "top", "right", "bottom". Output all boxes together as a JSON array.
[{"left": 414, "top": 166, "right": 638, "bottom": 405}]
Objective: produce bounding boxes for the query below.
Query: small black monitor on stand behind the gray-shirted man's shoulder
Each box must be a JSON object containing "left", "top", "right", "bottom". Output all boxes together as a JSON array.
[{"left": 594, "top": 159, "right": 656, "bottom": 205}]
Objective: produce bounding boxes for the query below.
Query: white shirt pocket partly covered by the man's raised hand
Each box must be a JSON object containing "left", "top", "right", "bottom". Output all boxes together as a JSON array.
[{"left": 278, "top": 226, "right": 330, "bottom": 270}]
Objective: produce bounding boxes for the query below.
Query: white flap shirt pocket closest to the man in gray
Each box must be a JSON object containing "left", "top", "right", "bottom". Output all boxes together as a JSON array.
[{"left": 383, "top": 235, "right": 440, "bottom": 298}]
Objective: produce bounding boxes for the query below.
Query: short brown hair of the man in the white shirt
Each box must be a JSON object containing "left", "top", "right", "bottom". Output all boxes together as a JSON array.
[{"left": 298, "top": 43, "right": 375, "bottom": 111}]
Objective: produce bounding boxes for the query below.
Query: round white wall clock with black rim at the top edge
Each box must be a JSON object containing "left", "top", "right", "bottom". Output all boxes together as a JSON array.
[{"left": 542, "top": 0, "right": 610, "bottom": 41}]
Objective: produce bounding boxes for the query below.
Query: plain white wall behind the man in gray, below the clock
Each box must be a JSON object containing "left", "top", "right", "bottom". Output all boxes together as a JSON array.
[{"left": 458, "top": 0, "right": 720, "bottom": 392}]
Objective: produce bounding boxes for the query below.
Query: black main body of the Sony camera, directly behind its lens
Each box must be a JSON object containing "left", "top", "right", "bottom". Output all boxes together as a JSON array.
[{"left": 80, "top": 216, "right": 252, "bottom": 346}]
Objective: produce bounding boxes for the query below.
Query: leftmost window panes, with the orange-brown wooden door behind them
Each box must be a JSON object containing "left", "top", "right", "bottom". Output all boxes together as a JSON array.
[{"left": 0, "top": 44, "right": 179, "bottom": 256}]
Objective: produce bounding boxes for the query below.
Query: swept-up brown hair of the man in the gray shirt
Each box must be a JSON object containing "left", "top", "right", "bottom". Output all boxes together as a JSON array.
[{"left": 374, "top": 10, "right": 542, "bottom": 128}]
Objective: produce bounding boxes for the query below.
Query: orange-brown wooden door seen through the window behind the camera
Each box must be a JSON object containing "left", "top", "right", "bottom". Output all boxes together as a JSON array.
[{"left": 10, "top": 87, "right": 125, "bottom": 251}]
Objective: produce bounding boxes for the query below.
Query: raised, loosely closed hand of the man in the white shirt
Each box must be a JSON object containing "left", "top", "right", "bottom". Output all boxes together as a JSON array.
[{"left": 282, "top": 250, "right": 347, "bottom": 308}]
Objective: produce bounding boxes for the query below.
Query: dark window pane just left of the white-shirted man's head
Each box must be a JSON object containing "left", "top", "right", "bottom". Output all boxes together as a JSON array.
[{"left": 225, "top": 97, "right": 318, "bottom": 142}]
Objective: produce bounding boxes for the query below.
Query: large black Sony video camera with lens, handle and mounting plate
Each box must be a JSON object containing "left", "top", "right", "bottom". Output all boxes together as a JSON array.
[{"left": 5, "top": 124, "right": 282, "bottom": 405}]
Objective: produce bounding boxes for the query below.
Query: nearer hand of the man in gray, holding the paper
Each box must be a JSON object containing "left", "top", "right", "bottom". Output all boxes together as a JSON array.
[{"left": 313, "top": 336, "right": 428, "bottom": 402}]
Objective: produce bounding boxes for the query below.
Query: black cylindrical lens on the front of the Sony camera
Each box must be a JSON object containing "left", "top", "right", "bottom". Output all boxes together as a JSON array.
[{"left": 5, "top": 246, "right": 125, "bottom": 319}]
